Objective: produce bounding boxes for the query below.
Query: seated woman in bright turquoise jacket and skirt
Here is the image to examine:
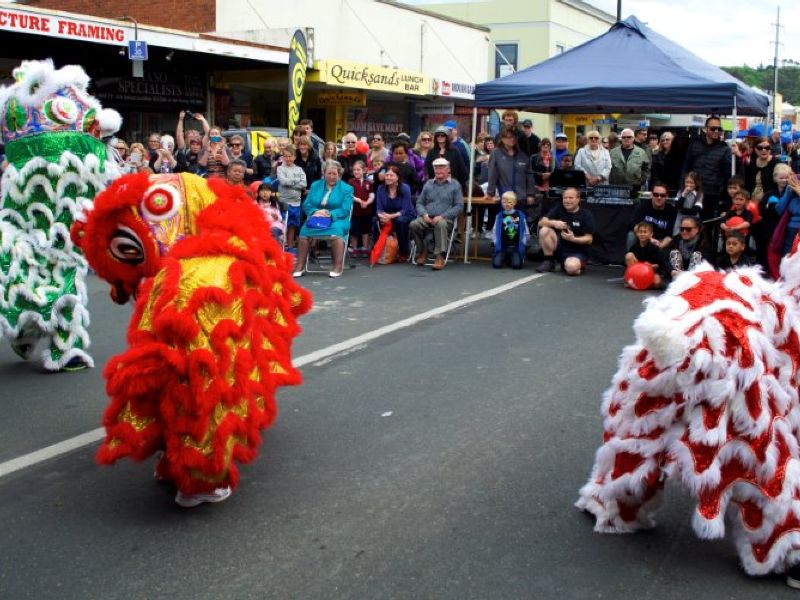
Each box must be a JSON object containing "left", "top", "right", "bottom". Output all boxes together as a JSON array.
[{"left": 293, "top": 160, "right": 353, "bottom": 277}]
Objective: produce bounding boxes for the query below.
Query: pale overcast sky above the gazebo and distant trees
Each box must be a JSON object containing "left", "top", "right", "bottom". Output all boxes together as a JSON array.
[{"left": 405, "top": 0, "right": 800, "bottom": 68}]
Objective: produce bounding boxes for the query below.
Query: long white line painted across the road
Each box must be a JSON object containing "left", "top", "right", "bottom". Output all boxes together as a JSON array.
[{"left": 0, "top": 273, "right": 544, "bottom": 478}]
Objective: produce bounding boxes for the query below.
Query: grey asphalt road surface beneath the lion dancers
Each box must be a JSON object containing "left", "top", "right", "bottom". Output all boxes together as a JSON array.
[{"left": 0, "top": 264, "right": 796, "bottom": 600}]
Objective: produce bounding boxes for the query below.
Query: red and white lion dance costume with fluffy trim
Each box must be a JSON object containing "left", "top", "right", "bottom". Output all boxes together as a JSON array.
[{"left": 576, "top": 241, "right": 800, "bottom": 575}]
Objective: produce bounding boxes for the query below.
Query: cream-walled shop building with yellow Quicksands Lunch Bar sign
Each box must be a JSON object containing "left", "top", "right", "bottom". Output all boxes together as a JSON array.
[{"left": 212, "top": 0, "right": 490, "bottom": 143}]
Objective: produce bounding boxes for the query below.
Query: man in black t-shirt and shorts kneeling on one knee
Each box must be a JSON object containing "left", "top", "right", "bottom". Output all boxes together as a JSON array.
[{"left": 536, "top": 187, "right": 594, "bottom": 275}]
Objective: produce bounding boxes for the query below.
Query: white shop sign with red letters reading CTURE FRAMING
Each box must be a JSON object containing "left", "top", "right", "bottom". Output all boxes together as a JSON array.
[{"left": 0, "top": 8, "right": 126, "bottom": 46}]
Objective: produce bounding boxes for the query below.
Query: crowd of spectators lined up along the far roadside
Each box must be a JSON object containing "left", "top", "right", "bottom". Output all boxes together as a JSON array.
[{"left": 31, "top": 110, "right": 800, "bottom": 283}]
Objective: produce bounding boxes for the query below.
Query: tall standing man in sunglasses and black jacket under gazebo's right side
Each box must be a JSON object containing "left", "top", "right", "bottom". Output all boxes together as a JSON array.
[{"left": 681, "top": 115, "right": 731, "bottom": 221}]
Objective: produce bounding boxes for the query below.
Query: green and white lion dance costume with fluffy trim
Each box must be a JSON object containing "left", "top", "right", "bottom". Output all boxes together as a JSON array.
[{"left": 0, "top": 60, "right": 122, "bottom": 371}]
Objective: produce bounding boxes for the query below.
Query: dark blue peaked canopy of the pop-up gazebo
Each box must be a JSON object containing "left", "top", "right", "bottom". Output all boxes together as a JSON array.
[{"left": 475, "top": 16, "right": 769, "bottom": 116}]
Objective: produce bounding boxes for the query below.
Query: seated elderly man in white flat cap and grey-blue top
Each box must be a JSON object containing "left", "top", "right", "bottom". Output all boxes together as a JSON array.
[{"left": 409, "top": 158, "right": 464, "bottom": 271}]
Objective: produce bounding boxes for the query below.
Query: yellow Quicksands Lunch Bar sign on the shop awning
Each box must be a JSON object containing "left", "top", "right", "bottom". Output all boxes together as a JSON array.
[{"left": 309, "top": 60, "right": 430, "bottom": 96}]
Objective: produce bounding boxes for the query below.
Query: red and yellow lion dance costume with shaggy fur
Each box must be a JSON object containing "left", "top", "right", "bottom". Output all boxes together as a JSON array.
[{"left": 72, "top": 173, "right": 311, "bottom": 494}]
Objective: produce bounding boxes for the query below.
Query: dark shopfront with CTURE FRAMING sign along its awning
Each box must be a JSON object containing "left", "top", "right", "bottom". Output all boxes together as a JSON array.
[{"left": 0, "top": 3, "right": 288, "bottom": 140}]
